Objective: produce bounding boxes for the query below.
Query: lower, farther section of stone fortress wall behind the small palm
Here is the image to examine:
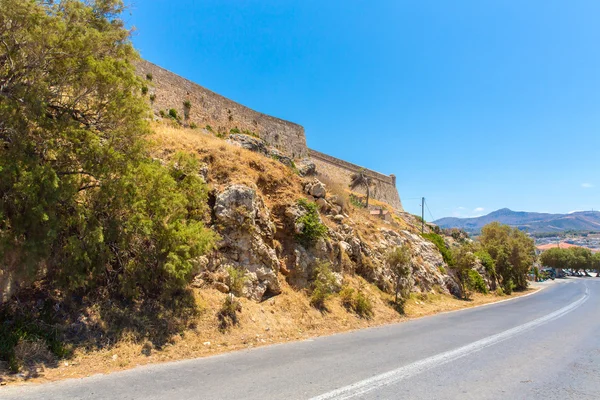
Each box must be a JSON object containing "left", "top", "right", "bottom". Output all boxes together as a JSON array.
[{"left": 308, "top": 149, "right": 403, "bottom": 211}]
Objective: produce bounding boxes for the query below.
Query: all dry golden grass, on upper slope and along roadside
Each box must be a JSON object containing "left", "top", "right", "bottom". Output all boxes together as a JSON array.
[{"left": 0, "top": 124, "right": 540, "bottom": 382}]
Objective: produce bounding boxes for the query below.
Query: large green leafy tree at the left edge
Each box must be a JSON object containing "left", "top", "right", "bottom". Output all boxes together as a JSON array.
[{"left": 0, "top": 0, "right": 214, "bottom": 298}]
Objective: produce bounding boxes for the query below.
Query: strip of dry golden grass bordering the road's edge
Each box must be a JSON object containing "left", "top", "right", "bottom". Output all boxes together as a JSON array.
[{"left": 0, "top": 277, "right": 529, "bottom": 383}]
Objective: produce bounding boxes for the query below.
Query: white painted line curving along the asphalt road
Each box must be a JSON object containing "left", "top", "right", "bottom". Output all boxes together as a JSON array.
[{"left": 311, "top": 286, "right": 589, "bottom": 400}]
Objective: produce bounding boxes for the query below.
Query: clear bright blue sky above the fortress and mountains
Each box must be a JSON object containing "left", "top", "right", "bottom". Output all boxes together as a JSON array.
[{"left": 126, "top": 0, "right": 600, "bottom": 220}]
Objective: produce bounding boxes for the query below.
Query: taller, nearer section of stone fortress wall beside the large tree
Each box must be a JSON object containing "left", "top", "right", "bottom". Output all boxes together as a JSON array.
[{"left": 137, "top": 60, "right": 307, "bottom": 159}]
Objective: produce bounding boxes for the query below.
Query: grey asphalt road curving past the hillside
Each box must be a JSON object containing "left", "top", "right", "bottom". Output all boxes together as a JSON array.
[{"left": 0, "top": 278, "right": 600, "bottom": 400}]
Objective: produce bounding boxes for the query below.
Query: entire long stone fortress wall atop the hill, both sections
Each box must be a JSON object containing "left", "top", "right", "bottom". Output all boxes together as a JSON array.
[{"left": 137, "top": 60, "right": 402, "bottom": 211}]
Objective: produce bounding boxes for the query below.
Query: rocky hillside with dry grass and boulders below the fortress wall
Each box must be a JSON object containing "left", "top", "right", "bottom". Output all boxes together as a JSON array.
[{"left": 154, "top": 123, "right": 466, "bottom": 301}]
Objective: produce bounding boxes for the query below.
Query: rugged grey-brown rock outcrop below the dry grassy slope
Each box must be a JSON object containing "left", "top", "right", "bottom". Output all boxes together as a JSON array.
[{"left": 200, "top": 179, "right": 460, "bottom": 301}]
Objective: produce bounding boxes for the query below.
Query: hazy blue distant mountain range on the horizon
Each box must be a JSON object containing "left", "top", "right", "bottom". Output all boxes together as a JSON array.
[{"left": 433, "top": 208, "right": 600, "bottom": 233}]
